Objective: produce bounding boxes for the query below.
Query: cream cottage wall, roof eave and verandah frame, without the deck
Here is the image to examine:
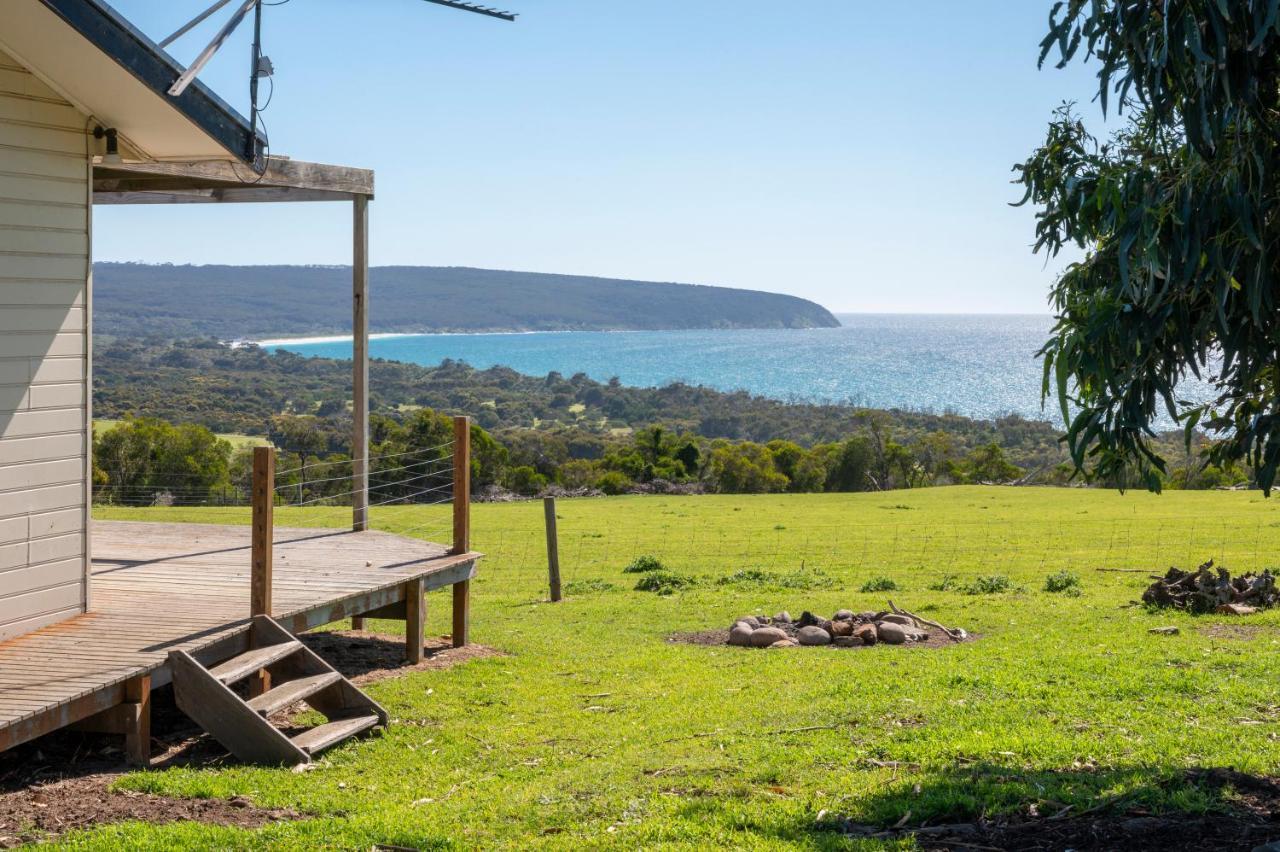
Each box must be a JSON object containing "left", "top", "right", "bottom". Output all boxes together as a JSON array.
[{"left": 0, "top": 0, "right": 372, "bottom": 641}]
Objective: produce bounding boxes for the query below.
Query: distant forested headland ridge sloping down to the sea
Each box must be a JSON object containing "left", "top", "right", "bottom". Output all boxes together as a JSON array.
[{"left": 93, "top": 264, "right": 840, "bottom": 340}]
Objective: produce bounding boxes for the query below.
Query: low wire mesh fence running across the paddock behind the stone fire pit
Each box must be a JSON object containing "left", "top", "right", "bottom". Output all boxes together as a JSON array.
[{"left": 407, "top": 498, "right": 1280, "bottom": 590}]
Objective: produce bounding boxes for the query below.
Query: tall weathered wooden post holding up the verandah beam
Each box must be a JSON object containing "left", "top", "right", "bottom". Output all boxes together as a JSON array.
[{"left": 351, "top": 196, "right": 369, "bottom": 532}]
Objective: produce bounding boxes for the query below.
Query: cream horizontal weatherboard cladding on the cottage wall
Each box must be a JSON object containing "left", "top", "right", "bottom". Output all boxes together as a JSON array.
[{"left": 0, "top": 51, "right": 92, "bottom": 641}]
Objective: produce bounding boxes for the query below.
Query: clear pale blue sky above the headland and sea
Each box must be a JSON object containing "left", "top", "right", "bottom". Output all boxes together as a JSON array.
[{"left": 95, "top": 0, "right": 1096, "bottom": 312}]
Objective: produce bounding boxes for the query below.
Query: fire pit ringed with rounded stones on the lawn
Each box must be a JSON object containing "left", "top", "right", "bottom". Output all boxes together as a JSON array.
[{"left": 728, "top": 601, "right": 969, "bottom": 647}]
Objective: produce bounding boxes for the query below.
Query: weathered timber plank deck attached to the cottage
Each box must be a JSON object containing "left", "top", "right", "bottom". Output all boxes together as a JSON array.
[{"left": 0, "top": 521, "right": 479, "bottom": 751}]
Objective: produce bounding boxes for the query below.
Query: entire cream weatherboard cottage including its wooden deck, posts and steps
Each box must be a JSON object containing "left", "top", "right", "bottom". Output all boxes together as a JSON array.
[{"left": 0, "top": 0, "right": 483, "bottom": 765}]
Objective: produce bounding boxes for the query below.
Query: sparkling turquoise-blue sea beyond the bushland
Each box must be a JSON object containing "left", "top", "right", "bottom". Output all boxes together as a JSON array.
[{"left": 264, "top": 313, "right": 1085, "bottom": 420}]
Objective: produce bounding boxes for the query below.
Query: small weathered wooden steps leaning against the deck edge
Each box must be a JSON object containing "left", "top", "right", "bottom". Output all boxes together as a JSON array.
[{"left": 169, "top": 615, "right": 387, "bottom": 765}]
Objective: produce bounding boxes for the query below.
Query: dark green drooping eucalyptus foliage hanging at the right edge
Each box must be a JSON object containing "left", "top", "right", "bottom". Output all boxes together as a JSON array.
[{"left": 1016, "top": 0, "right": 1280, "bottom": 493}]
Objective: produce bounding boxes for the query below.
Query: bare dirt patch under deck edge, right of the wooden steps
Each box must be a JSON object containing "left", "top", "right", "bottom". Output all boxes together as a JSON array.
[{"left": 298, "top": 631, "right": 504, "bottom": 684}]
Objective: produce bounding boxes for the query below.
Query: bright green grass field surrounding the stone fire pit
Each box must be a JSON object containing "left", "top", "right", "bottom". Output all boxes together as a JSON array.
[{"left": 64, "top": 487, "right": 1280, "bottom": 849}]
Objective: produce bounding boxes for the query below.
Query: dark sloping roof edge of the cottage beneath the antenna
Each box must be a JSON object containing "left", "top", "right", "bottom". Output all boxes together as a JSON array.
[{"left": 41, "top": 0, "right": 266, "bottom": 168}]
